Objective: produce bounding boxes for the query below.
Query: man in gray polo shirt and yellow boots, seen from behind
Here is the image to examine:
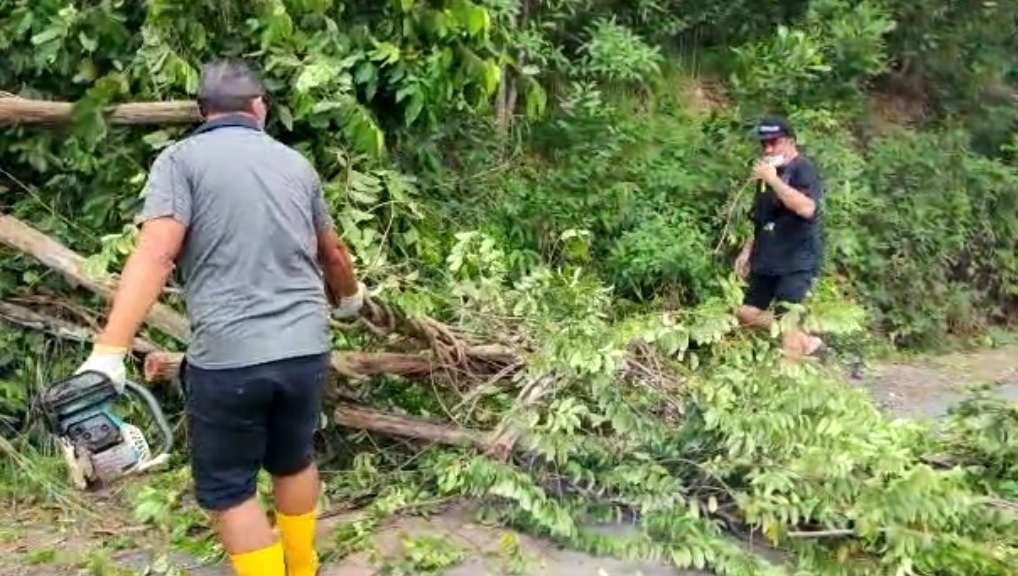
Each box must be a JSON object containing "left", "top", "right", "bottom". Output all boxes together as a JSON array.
[{"left": 72, "top": 60, "right": 364, "bottom": 576}]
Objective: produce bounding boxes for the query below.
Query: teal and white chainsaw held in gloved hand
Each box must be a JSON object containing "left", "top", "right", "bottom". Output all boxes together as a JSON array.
[{"left": 40, "top": 371, "right": 173, "bottom": 489}]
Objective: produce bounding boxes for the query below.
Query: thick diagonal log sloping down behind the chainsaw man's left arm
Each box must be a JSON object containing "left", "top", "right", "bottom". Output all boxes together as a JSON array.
[{"left": 0, "top": 215, "right": 190, "bottom": 344}]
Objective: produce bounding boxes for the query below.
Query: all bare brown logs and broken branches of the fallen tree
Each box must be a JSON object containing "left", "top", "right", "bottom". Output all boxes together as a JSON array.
[{"left": 0, "top": 93, "right": 574, "bottom": 455}]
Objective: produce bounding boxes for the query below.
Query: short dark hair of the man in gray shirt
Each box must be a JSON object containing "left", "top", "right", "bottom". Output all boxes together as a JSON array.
[{"left": 197, "top": 58, "right": 265, "bottom": 116}]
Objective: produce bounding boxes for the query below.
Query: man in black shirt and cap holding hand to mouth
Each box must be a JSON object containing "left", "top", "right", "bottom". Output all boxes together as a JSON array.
[{"left": 735, "top": 118, "right": 824, "bottom": 357}]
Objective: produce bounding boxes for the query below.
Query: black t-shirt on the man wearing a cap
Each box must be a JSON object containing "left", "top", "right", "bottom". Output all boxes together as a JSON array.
[{"left": 749, "top": 155, "right": 824, "bottom": 276}]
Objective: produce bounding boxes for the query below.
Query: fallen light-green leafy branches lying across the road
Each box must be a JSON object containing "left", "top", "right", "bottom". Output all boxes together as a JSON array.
[{"left": 5, "top": 237, "right": 1018, "bottom": 575}]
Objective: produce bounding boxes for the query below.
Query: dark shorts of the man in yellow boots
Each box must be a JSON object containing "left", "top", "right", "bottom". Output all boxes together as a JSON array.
[{"left": 183, "top": 354, "right": 329, "bottom": 511}]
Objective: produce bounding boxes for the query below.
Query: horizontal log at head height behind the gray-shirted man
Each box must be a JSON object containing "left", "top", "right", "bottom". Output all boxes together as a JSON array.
[{"left": 0, "top": 95, "right": 202, "bottom": 126}]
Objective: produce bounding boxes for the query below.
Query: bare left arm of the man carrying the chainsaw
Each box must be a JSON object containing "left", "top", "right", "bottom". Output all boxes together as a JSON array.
[{"left": 96, "top": 218, "right": 186, "bottom": 349}]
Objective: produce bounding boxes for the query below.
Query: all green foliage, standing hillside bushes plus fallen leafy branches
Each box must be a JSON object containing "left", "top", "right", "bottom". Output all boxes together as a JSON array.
[{"left": 0, "top": 0, "right": 1018, "bottom": 576}]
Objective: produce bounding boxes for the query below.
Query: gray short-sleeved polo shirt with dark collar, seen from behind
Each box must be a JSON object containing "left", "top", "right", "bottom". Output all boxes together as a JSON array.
[{"left": 136, "top": 115, "right": 332, "bottom": 369}]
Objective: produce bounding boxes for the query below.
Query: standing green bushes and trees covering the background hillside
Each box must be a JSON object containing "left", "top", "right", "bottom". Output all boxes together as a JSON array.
[{"left": 0, "top": 0, "right": 1016, "bottom": 344}]
